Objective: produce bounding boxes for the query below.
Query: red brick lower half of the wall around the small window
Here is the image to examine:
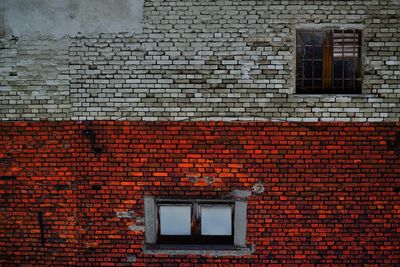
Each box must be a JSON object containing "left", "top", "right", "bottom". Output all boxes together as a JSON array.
[{"left": 0, "top": 121, "right": 400, "bottom": 266}]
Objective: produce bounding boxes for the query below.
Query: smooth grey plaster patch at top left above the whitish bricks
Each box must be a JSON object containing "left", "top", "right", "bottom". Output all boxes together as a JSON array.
[{"left": 0, "top": 0, "right": 143, "bottom": 38}]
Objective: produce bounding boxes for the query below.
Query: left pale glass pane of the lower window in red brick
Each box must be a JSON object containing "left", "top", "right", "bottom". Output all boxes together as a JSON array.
[{"left": 159, "top": 205, "right": 191, "bottom": 235}]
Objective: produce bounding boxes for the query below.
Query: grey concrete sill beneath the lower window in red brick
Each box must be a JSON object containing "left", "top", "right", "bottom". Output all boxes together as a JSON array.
[{"left": 143, "top": 244, "right": 254, "bottom": 256}]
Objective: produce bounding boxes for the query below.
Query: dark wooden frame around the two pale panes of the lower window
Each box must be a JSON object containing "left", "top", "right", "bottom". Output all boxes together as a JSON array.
[{"left": 155, "top": 200, "right": 235, "bottom": 245}]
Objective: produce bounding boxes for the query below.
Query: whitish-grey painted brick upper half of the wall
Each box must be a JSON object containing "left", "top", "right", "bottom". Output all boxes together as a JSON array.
[{"left": 0, "top": 0, "right": 400, "bottom": 122}]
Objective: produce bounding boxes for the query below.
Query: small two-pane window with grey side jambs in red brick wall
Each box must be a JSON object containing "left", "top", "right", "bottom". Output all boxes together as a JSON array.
[{"left": 145, "top": 197, "right": 247, "bottom": 249}]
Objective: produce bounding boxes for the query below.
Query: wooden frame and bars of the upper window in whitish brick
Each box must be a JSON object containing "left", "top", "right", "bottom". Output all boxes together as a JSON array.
[{"left": 296, "top": 27, "right": 362, "bottom": 94}]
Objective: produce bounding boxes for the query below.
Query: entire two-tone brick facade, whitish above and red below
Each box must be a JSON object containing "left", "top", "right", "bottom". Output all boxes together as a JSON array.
[{"left": 0, "top": 0, "right": 400, "bottom": 266}]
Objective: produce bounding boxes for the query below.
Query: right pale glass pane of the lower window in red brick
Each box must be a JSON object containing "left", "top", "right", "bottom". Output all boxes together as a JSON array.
[{"left": 200, "top": 205, "right": 232, "bottom": 235}]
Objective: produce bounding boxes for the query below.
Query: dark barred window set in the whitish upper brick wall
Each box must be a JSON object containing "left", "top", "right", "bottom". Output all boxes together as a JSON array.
[{"left": 296, "top": 29, "right": 362, "bottom": 94}]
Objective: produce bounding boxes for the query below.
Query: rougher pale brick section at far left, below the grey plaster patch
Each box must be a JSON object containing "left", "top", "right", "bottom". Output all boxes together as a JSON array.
[{"left": 0, "top": 38, "right": 71, "bottom": 120}]
